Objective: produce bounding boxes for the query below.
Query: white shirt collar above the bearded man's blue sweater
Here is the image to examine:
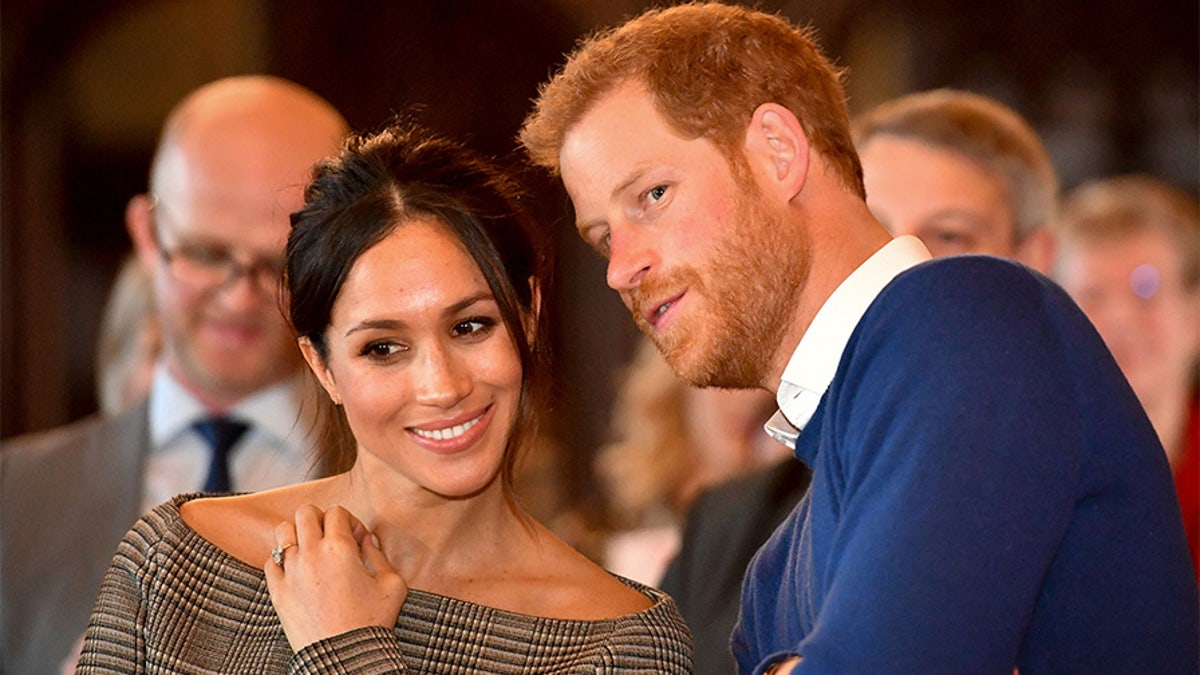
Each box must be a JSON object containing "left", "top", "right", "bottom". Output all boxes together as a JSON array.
[{"left": 764, "top": 235, "right": 931, "bottom": 448}]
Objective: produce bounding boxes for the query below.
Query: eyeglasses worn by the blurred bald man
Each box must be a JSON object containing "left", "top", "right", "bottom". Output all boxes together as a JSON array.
[{"left": 151, "top": 196, "right": 283, "bottom": 294}]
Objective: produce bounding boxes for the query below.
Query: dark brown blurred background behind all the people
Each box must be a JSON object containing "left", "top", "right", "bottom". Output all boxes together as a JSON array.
[{"left": 0, "top": 0, "right": 1200, "bottom": 504}]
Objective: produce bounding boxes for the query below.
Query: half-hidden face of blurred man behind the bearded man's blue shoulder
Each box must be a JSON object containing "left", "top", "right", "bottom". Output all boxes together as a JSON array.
[{"left": 858, "top": 135, "right": 1018, "bottom": 258}]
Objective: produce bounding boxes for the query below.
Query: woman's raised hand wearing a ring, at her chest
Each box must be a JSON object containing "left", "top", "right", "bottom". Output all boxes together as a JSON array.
[{"left": 263, "top": 506, "right": 408, "bottom": 651}]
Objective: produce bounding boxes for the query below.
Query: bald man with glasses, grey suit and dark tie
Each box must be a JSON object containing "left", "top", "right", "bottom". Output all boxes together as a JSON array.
[{"left": 0, "top": 76, "right": 347, "bottom": 675}]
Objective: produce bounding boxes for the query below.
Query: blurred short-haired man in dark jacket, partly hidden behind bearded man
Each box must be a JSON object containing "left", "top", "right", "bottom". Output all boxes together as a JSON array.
[{"left": 661, "top": 89, "right": 1058, "bottom": 675}]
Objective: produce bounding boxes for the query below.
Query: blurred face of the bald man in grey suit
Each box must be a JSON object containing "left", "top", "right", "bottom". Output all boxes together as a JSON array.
[{"left": 154, "top": 144, "right": 302, "bottom": 402}]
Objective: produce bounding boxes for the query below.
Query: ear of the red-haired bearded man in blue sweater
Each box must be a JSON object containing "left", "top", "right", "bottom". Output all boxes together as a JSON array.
[{"left": 745, "top": 103, "right": 810, "bottom": 202}]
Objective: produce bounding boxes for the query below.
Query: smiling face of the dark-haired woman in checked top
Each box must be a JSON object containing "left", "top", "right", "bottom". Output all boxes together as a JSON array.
[{"left": 301, "top": 220, "right": 522, "bottom": 497}]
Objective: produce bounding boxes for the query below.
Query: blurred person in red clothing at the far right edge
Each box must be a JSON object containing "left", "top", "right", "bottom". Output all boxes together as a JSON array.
[{"left": 1054, "top": 175, "right": 1200, "bottom": 574}]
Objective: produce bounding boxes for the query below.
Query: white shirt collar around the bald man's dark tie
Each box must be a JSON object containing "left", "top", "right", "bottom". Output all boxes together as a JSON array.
[{"left": 150, "top": 362, "right": 308, "bottom": 448}]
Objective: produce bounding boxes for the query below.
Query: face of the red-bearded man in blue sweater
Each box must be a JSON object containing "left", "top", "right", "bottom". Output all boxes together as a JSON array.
[{"left": 560, "top": 85, "right": 808, "bottom": 388}]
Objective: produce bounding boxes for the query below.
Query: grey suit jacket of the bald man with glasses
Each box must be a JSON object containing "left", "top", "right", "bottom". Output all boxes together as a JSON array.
[{"left": 0, "top": 402, "right": 150, "bottom": 675}]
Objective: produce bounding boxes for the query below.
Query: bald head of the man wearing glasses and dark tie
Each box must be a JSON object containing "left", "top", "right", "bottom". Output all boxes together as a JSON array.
[{"left": 126, "top": 76, "right": 348, "bottom": 408}]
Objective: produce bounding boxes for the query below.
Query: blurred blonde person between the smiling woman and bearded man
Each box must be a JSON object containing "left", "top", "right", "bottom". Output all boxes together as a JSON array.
[{"left": 592, "top": 339, "right": 787, "bottom": 585}]
